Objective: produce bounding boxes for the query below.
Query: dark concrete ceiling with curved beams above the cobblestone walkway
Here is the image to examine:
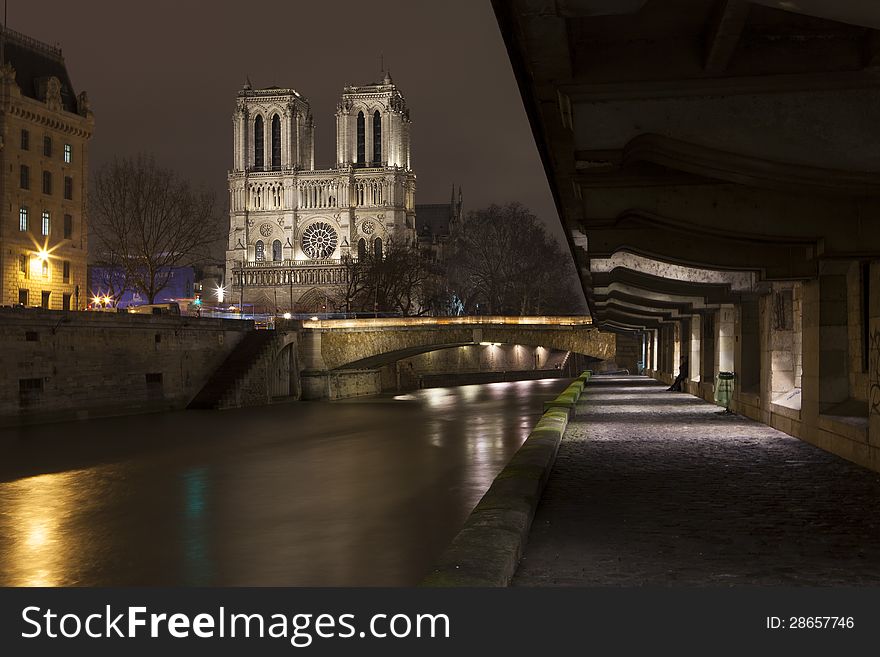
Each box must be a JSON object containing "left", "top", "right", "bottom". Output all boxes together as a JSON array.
[{"left": 493, "top": 0, "right": 880, "bottom": 330}]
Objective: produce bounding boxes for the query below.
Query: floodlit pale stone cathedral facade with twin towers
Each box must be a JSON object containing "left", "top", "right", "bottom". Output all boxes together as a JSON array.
[{"left": 226, "top": 74, "right": 416, "bottom": 313}]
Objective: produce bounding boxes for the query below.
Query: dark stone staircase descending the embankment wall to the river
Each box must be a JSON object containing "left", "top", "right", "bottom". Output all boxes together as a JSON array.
[{"left": 187, "top": 329, "right": 277, "bottom": 409}]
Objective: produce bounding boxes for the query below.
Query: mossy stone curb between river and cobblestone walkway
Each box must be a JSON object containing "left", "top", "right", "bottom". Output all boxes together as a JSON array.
[{"left": 420, "top": 373, "right": 589, "bottom": 587}]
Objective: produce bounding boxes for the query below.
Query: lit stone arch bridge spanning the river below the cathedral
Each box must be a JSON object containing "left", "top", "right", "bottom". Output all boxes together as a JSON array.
[{"left": 297, "top": 316, "right": 616, "bottom": 399}]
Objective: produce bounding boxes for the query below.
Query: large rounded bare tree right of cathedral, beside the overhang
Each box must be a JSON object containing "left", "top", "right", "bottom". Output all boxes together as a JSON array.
[{"left": 447, "top": 203, "right": 584, "bottom": 315}]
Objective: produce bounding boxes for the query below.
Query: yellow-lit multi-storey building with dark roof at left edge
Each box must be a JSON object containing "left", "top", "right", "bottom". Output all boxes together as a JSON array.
[{"left": 0, "top": 30, "right": 94, "bottom": 310}]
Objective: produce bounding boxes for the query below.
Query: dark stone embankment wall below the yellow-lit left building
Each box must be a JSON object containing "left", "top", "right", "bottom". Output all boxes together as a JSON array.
[{"left": 0, "top": 309, "right": 252, "bottom": 425}]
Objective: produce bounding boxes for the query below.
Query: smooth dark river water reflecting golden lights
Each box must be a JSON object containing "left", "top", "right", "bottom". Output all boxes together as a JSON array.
[{"left": 0, "top": 379, "right": 568, "bottom": 586}]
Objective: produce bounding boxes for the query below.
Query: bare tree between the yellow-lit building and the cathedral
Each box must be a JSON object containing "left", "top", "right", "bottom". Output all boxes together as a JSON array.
[{"left": 90, "top": 155, "right": 225, "bottom": 303}]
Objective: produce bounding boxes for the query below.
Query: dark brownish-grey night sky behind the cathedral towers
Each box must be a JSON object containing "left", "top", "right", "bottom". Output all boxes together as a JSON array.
[{"left": 8, "top": 0, "right": 561, "bottom": 236}]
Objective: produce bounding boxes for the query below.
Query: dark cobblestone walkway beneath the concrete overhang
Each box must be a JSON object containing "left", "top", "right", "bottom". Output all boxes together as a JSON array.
[{"left": 513, "top": 376, "right": 880, "bottom": 586}]
